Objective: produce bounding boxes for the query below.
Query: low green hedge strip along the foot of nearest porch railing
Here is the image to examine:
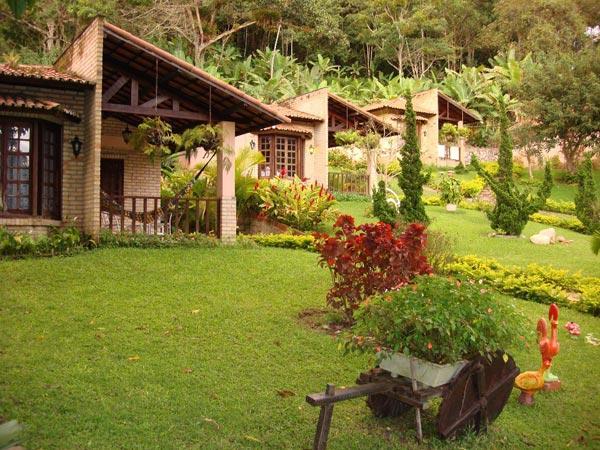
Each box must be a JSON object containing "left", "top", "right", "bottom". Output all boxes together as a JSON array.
[{"left": 98, "top": 230, "right": 220, "bottom": 248}]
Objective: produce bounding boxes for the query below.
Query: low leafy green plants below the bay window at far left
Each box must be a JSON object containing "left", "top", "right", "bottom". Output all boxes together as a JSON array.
[{"left": 0, "top": 227, "right": 87, "bottom": 258}]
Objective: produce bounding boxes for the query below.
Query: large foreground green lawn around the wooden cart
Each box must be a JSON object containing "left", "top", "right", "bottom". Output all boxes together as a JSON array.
[{"left": 0, "top": 248, "right": 600, "bottom": 449}]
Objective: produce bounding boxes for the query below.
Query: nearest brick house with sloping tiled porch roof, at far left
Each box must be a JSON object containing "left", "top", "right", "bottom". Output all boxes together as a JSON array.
[{"left": 0, "top": 18, "right": 289, "bottom": 239}]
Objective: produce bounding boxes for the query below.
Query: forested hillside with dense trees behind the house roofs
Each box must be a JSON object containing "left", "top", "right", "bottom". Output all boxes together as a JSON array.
[{"left": 0, "top": 0, "right": 600, "bottom": 156}]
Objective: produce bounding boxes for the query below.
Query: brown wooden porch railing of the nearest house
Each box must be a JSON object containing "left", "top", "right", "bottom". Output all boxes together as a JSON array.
[{"left": 100, "top": 194, "right": 221, "bottom": 237}]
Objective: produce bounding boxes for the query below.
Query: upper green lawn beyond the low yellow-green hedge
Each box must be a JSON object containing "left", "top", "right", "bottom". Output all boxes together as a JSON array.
[{"left": 336, "top": 201, "right": 600, "bottom": 276}]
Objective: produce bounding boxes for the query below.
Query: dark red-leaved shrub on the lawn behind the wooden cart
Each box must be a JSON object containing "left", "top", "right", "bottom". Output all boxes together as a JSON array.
[{"left": 315, "top": 215, "right": 431, "bottom": 320}]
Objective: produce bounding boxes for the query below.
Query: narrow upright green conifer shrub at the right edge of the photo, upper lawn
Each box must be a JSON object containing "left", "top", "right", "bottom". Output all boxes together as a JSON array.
[{"left": 575, "top": 154, "right": 600, "bottom": 233}]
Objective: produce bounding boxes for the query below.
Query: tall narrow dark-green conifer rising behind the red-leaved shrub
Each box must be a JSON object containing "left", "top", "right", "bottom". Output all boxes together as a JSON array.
[{"left": 398, "top": 92, "right": 429, "bottom": 223}]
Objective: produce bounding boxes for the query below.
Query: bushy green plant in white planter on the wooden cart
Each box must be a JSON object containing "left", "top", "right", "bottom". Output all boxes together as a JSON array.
[{"left": 346, "top": 276, "right": 527, "bottom": 387}]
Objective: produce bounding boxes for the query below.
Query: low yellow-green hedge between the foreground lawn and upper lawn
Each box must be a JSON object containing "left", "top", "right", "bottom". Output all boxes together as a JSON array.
[{"left": 447, "top": 255, "right": 600, "bottom": 315}]
